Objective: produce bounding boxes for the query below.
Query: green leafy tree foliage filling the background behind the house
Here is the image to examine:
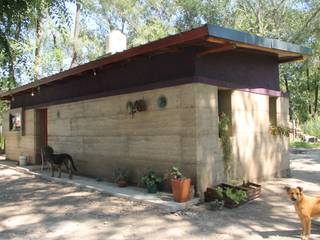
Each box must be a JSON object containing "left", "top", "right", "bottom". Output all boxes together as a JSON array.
[{"left": 0, "top": 0, "right": 320, "bottom": 123}]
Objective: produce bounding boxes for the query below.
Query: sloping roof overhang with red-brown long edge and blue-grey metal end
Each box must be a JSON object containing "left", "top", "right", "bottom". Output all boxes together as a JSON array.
[{"left": 0, "top": 24, "right": 312, "bottom": 100}]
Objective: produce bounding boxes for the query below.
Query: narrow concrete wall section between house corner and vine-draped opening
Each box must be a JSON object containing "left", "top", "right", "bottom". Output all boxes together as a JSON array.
[{"left": 195, "top": 84, "right": 223, "bottom": 194}]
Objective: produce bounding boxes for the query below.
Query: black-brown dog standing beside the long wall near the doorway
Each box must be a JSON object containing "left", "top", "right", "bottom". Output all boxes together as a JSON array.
[{"left": 43, "top": 146, "right": 77, "bottom": 179}]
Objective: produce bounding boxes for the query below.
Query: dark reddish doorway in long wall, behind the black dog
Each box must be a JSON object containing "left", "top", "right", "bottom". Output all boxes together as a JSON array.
[{"left": 35, "top": 108, "right": 48, "bottom": 164}]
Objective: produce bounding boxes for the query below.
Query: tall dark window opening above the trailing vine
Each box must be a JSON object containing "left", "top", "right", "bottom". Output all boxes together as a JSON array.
[{"left": 218, "top": 89, "right": 232, "bottom": 135}]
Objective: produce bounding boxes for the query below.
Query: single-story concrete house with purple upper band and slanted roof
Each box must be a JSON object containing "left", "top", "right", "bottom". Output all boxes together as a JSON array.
[{"left": 0, "top": 24, "right": 311, "bottom": 197}]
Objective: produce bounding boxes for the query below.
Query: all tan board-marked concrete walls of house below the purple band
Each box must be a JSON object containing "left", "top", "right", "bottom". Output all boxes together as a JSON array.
[{"left": 6, "top": 83, "right": 289, "bottom": 196}]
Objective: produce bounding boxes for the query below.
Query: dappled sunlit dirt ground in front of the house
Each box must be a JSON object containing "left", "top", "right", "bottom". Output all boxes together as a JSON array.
[{"left": 0, "top": 150, "right": 320, "bottom": 240}]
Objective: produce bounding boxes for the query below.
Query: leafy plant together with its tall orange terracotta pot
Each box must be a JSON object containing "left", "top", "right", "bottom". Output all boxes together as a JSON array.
[{"left": 170, "top": 167, "right": 191, "bottom": 202}]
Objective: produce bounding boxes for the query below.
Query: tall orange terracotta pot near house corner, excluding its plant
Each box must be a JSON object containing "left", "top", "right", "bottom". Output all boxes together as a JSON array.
[{"left": 171, "top": 178, "right": 191, "bottom": 202}]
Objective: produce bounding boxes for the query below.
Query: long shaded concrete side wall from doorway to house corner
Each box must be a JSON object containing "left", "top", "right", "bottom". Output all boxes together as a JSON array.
[{"left": 48, "top": 85, "right": 196, "bottom": 186}]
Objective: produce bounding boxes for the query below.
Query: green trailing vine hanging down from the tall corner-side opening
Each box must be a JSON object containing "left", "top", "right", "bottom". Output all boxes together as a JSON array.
[{"left": 219, "top": 113, "right": 233, "bottom": 179}]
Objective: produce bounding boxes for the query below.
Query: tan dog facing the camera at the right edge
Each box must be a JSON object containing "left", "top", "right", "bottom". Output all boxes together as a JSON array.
[{"left": 285, "top": 187, "right": 320, "bottom": 240}]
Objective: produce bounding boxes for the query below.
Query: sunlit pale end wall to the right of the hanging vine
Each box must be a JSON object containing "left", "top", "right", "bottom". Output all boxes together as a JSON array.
[{"left": 232, "top": 91, "right": 289, "bottom": 180}]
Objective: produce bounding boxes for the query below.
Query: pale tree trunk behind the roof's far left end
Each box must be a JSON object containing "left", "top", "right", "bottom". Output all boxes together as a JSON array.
[{"left": 34, "top": 11, "right": 44, "bottom": 80}]
